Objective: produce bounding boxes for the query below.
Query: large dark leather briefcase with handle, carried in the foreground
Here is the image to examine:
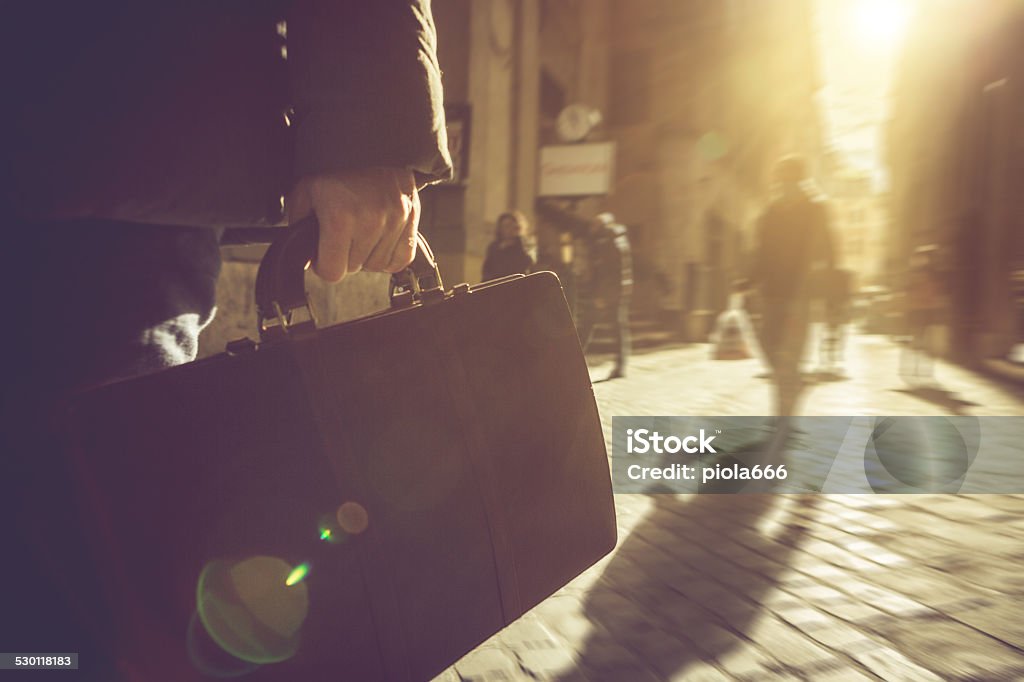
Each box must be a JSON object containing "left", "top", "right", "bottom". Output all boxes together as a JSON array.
[{"left": 66, "top": 220, "right": 615, "bottom": 681}]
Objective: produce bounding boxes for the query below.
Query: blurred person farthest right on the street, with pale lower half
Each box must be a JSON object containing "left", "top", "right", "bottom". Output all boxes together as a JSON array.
[{"left": 899, "top": 244, "right": 945, "bottom": 387}]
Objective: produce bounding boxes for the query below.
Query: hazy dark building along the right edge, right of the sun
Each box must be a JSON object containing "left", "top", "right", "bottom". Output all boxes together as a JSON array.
[{"left": 887, "top": 0, "right": 1024, "bottom": 363}]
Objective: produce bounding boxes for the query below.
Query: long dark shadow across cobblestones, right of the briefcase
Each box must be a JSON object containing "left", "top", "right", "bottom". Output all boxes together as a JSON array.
[{"left": 564, "top": 436, "right": 815, "bottom": 681}]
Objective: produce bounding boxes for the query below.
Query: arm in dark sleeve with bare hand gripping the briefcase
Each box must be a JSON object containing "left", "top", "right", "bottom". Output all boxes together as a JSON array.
[{"left": 287, "top": 0, "right": 451, "bottom": 282}]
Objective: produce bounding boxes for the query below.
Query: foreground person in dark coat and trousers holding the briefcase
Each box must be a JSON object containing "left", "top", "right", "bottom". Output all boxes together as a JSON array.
[{"left": 0, "top": 0, "right": 452, "bottom": 679}]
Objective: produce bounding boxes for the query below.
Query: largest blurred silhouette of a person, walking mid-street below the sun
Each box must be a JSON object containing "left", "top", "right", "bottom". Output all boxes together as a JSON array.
[{"left": 751, "top": 156, "right": 835, "bottom": 417}]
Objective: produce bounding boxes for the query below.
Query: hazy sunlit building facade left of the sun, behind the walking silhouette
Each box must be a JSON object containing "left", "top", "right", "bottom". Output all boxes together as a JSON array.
[{"left": 608, "top": 0, "right": 821, "bottom": 333}]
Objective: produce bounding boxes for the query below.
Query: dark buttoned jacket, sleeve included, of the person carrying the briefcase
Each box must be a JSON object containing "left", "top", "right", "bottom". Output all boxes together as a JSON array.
[{"left": 0, "top": 0, "right": 451, "bottom": 225}]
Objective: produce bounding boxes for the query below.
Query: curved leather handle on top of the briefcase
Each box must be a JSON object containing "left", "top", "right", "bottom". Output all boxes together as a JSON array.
[{"left": 255, "top": 215, "right": 444, "bottom": 342}]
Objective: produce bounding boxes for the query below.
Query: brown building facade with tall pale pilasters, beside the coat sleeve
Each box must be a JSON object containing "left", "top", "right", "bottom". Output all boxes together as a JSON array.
[{"left": 422, "top": 0, "right": 610, "bottom": 282}]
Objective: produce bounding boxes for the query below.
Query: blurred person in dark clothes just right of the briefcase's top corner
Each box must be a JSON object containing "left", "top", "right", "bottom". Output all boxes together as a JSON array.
[{"left": 580, "top": 213, "right": 633, "bottom": 379}]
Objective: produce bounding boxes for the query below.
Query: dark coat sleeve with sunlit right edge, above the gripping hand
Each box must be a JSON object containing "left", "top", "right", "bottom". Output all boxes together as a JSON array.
[{"left": 288, "top": 0, "right": 452, "bottom": 185}]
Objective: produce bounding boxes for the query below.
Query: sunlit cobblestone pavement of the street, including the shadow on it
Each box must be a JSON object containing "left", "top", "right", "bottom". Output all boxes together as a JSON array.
[{"left": 437, "top": 327, "right": 1024, "bottom": 682}]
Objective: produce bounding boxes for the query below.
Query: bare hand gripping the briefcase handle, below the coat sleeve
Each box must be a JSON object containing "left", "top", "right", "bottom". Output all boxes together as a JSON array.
[{"left": 285, "top": 168, "right": 420, "bottom": 282}]
